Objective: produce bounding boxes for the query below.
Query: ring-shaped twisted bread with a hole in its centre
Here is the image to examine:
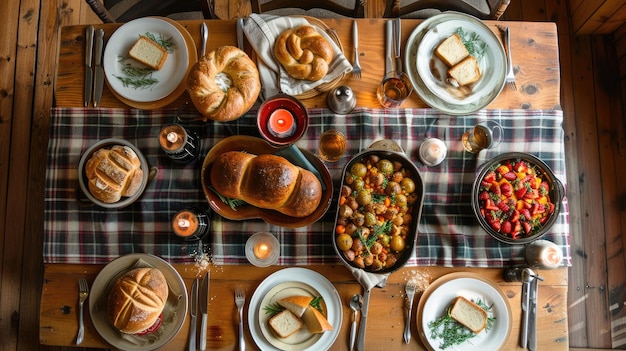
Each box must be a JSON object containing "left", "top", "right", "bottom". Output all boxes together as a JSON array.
[{"left": 187, "top": 46, "right": 261, "bottom": 122}]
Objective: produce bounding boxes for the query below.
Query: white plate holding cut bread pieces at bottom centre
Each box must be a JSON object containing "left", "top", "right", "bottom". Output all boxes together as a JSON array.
[{"left": 248, "top": 267, "right": 343, "bottom": 351}]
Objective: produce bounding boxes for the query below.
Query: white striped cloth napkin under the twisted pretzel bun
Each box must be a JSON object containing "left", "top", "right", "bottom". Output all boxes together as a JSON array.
[{"left": 243, "top": 14, "right": 352, "bottom": 99}]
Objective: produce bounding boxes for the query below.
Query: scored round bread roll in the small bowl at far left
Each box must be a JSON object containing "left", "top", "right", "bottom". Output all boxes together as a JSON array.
[{"left": 85, "top": 145, "right": 143, "bottom": 203}]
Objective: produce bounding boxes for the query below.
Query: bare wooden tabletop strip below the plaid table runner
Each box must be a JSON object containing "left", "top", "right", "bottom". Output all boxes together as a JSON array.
[{"left": 40, "top": 264, "right": 568, "bottom": 350}]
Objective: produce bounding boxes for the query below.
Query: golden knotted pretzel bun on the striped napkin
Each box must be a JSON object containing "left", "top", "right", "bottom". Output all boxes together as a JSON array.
[{"left": 274, "top": 25, "right": 335, "bottom": 81}]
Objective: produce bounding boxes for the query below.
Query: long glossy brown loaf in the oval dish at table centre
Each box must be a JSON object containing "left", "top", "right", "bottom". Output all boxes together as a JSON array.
[{"left": 210, "top": 151, "right": 322, "bottom": 217}]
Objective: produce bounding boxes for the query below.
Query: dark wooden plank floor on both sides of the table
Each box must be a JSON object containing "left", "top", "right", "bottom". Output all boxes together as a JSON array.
[{"left": 0, "top": 0, "right": 626, "bottom": 350}]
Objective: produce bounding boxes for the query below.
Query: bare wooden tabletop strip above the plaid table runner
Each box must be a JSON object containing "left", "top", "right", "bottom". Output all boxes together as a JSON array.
[{"left": 55, "top": 19, "right": 560, "bottom": 110}]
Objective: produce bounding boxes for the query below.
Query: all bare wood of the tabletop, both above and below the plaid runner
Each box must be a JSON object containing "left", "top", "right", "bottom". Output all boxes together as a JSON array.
[{"left": 40, "top": 19, "right": 568, "bottom": 350}]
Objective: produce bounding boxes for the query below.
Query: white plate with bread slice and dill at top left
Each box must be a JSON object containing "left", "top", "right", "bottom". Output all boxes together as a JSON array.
[{"left": 103, "top": 17, "right": 189, "bottom": 102}]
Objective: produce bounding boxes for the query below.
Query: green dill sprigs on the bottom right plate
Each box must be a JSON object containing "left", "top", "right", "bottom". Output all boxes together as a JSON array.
[{"left": 428, "top": 300, "right": 496, "bottom": 350}]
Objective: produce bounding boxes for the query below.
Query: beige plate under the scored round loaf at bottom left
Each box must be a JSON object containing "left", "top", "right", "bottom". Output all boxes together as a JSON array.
[{"left": 89, "top": 254, "right": 187, "bottom": 351}]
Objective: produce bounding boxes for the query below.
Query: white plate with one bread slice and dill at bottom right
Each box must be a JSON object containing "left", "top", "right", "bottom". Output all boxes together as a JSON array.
[{"left": 416, "top": 272, "right": 512, "bottom": 351}]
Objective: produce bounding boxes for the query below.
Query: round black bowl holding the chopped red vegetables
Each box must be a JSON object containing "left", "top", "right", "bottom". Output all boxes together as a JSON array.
[{"left": 472, "top": 152, "right": 565, "bottom": 244}]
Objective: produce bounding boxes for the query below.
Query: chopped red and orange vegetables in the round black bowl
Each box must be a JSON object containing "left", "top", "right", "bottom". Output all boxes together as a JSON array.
[{"left": 478, "top": 160, "right": 555, "bottom": 239}]
